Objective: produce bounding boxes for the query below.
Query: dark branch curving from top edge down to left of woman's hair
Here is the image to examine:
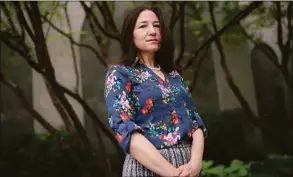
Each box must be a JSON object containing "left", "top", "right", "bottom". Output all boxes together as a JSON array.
[{"left": 80, "top": 1, "right": 120, "bottom": 41}]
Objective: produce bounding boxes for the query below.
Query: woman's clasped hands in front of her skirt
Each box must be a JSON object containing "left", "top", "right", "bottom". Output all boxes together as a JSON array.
[{"left": 179, "top": 162, "right": 201, "bottom": 177}]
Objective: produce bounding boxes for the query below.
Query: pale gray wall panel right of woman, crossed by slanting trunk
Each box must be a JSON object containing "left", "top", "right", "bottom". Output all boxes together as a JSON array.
[{"left": 212, "top": 42, "right": 257, "bottom": 113}]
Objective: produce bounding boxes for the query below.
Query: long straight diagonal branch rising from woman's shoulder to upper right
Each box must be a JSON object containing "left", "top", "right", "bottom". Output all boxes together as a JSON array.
[{"left": 179, "top": 1, "right": 263, "bottom": 70}]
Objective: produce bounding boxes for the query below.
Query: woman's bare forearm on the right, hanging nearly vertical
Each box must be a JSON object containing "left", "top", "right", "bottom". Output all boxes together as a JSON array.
[{"left": 190, "top": 128, "right": 204, "bottom": 163}]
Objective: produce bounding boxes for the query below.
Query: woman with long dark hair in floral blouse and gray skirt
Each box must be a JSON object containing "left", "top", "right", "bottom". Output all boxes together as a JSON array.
[{"left": 105, "top": 7, "right": 207, "bottom": 176}]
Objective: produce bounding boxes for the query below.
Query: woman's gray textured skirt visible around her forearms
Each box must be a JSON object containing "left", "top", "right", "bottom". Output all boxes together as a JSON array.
[{"left": 122, "top": 142, "right": 191, "bottom": 177}]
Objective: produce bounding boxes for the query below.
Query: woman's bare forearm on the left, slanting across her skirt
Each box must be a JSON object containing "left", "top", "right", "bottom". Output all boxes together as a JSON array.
[{"left": 130, "top": 132, "right": 177, "bottom": 176}]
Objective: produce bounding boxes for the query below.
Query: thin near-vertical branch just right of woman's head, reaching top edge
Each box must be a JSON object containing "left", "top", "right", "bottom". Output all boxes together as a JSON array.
[{"left": 175, "top": 1, "right": 185, "bottom": 68}]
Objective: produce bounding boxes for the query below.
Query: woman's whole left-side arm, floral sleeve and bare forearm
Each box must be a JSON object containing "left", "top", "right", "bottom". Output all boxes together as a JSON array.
[{"left": 104, "top": 66, "right": 180, "bottom": 176}]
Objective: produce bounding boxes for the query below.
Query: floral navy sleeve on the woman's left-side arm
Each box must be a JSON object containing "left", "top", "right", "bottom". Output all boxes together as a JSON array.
[{"left": 104, "top": 65, "right": 141, "bottom": 153}]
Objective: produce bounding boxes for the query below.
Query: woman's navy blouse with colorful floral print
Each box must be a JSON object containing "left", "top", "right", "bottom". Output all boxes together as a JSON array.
[{"left": 104, "top": 63, "right": 207, "bottom": 153}]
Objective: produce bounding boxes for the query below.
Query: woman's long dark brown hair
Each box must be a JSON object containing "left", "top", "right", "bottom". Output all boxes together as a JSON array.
[{"left": 119, "top": 6, "right": 175, "bottom": 72}]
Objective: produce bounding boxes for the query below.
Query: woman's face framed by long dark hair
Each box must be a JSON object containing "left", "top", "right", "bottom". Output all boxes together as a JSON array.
[{"left": 133, "top": 10, "right": 161, "bottom": 53}]
